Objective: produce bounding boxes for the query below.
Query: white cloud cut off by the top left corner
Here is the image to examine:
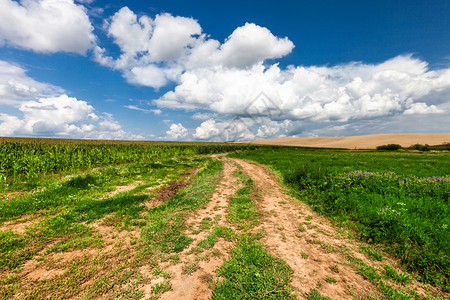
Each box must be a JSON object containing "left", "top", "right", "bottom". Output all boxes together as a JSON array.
[{"left": 0, "top": 0, "right": 95, "bottom": 54}]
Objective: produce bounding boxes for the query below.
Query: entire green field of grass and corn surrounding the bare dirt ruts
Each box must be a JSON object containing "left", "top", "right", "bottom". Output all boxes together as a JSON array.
[{"left": 0, "top": 138, "right": 450, "bottom": 299}]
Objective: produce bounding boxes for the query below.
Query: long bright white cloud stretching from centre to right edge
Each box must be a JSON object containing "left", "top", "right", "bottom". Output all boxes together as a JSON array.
[{"left": 155, "top": 56, "right": 450, "bottom": 122}]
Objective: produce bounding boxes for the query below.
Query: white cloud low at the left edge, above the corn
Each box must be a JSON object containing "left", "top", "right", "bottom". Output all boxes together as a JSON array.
[{"left": 0, "top": 61, "right": 143, "bottom": 139}]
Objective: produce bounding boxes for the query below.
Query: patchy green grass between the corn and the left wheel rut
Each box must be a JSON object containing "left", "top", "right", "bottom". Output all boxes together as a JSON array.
[{"left": 0, "top": 156, "right": 224, "bottom": 299}]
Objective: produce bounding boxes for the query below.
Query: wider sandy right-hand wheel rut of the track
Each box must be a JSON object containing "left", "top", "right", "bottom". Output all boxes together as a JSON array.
[{"left": 235, "top": 160, "right": 377, "bottom": 299}]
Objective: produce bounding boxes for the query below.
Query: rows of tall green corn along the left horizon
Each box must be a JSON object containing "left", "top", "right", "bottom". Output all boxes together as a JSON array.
[{"left": 0, "top": 139, "right": 256, "bottom": 181}]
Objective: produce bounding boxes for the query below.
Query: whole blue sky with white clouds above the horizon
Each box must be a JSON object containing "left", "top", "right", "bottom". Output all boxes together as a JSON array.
[{"left": 0, "top": 0, "right": 450, "bottom": 141}]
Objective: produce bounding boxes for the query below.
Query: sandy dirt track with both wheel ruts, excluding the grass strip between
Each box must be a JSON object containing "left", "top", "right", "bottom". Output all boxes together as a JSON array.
[{"left": 149, "top": 158, "right": 438, "bottom": 299}]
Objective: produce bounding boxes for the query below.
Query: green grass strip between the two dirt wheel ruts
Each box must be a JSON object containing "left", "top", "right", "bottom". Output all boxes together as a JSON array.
[{"left": 212, "top": 167, "right": 296, "bottom": 299}]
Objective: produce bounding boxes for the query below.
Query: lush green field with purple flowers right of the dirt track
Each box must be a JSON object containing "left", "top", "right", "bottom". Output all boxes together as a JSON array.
[{"left": 232, "top": 148, "right": 450, "bottom": 291}]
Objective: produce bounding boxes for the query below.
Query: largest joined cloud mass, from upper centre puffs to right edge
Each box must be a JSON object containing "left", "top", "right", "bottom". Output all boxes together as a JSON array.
[{"left": 92, "top": 7, "right": 450, "bottom": 139}]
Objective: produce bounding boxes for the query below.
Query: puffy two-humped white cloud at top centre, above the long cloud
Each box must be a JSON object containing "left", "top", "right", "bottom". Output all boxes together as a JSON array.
[{"left": 94, "top": 7, "right": 294, "bottom": 88}]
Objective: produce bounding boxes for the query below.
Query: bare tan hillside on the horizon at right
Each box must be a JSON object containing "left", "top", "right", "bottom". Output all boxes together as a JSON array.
[{"left": 250, "top": 133, "right": 450, "bottom": 149}]
